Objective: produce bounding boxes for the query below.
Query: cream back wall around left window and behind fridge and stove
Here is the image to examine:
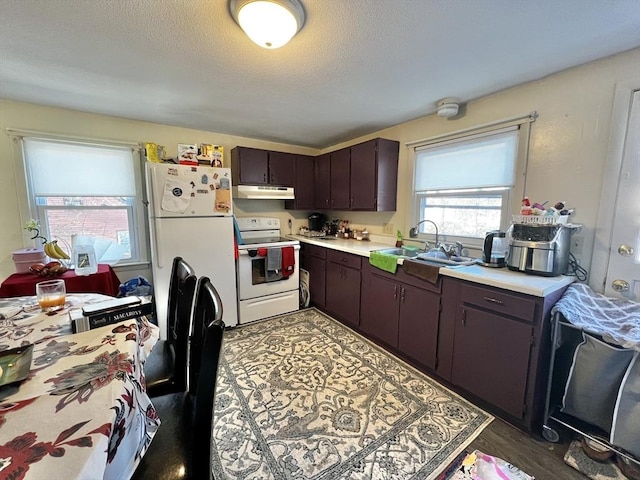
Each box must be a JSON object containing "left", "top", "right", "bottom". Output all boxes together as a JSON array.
[{"left": 0, "top": 99, "right": 318, "bottom": 281}]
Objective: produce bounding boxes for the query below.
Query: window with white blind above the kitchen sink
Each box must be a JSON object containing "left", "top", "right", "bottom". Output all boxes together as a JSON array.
[{"left": 414, "top": 125, "right": 519, "bottom": 241}]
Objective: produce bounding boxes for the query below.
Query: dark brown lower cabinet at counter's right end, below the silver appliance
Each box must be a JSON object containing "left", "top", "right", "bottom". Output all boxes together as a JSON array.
[{"left": 436, "top": 277, "right": 566, "bottom": 433}]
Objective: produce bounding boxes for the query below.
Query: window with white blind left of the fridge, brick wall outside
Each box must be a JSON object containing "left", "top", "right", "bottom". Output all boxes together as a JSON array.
[{"left": 22, "top": 137, "right": 146, "bottom": 263}]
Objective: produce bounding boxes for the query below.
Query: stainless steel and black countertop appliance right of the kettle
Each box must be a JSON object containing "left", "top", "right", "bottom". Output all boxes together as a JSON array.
[{"left": 507, "top": 223, "right": 580, "bottom": 277}]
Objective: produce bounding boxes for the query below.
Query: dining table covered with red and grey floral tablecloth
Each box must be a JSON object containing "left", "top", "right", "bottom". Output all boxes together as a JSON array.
[{"left": 0, "top": 293, "right": 160, "bottom": 480}]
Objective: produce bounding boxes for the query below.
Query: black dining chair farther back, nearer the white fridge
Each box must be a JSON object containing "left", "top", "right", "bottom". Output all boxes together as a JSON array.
[{"left": 144, "top": 257, "right": 197, "bottom": 397}]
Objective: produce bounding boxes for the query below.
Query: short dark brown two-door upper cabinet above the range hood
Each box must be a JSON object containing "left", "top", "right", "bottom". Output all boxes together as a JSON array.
[{"left": 231, "top": 147, "right": 295, "bottom": 187}]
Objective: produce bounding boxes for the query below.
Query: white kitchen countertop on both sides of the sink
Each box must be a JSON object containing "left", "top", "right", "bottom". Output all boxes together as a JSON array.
[{"left": 288, "top": 235, "right": 575, "bottom": 297}]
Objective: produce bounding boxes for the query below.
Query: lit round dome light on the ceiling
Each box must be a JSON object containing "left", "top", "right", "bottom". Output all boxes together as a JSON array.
[{"left": 229, "top": 0, "right": 304, "bottom": 48}]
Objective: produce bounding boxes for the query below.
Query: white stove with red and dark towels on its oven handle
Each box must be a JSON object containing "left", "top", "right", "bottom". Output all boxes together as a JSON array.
[{"left": 236, "top": 217, "right": 300, "bottom": 324}]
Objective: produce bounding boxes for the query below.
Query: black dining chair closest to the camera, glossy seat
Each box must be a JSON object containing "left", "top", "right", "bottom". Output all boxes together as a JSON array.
[{"left": 133, "top": 277, "right": 224, "bottom": 480}]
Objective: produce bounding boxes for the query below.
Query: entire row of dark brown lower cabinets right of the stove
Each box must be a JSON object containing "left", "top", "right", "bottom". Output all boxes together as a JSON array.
[{"left": 303, "top": 245, "right": 566, "bottom": 433}]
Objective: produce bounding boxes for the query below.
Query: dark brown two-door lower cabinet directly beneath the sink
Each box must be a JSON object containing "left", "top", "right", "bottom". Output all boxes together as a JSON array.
[{"left": 360, "top": 267, "right": 440, "bottom": 369}]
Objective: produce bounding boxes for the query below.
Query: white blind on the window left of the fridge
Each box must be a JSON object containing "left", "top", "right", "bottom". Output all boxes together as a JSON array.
[{"left": 23, "top": 138, "right": 136, "bottom": 197}]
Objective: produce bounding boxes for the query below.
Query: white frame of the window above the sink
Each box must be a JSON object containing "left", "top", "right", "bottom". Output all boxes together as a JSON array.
[{"left": 406, "top": 111, "right": 538, "bottom": 249}]
